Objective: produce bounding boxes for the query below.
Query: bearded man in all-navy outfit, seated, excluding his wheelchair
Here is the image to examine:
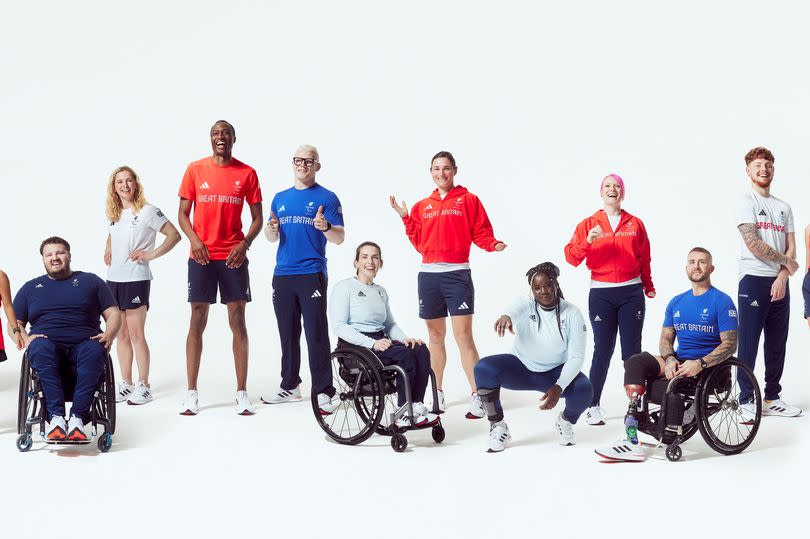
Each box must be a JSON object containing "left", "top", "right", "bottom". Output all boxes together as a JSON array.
[{"left": 14, "top": 237, "right": 121, "bottom": 443}]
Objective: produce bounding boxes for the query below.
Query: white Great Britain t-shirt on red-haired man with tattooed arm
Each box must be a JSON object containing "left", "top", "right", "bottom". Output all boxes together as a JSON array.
[{"left": 737, "top": 190, "right": 794, "bottom": 279}]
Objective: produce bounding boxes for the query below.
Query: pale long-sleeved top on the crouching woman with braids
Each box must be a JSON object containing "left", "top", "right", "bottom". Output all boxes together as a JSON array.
[{"left": 506, "top": 298, "right": 588, "bottom": 389}]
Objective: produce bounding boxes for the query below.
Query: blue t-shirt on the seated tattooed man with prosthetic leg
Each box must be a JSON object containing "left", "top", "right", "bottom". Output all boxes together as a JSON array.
[{"left": 664, "top": 286, "right": 737, "bottom": 361}]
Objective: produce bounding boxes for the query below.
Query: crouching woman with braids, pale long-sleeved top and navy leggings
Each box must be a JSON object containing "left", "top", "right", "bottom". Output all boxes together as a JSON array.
[{"left": 475, "top": 262, "right": 593, "bottom": 453}]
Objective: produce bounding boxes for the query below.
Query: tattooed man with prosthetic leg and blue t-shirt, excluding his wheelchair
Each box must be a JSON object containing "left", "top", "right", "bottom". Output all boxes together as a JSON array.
[{"left": 595, "top": 247, "right": 745, "bottom": 462}]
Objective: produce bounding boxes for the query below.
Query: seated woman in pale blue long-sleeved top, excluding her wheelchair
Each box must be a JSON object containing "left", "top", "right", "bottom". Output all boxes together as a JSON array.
[{"left": 329, "top": 241, "right": 438, "bottom": 427}]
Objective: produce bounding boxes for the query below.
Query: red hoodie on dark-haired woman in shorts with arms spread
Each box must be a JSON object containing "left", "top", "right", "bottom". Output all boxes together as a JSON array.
[{"left": 402, "top": 185, "right": 500, "bottom": 264}]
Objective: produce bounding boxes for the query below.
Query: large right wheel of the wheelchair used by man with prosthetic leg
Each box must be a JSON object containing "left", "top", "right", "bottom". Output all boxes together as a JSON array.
[{"left": 695, "top": 359, "right": 762, "bottom": 455}]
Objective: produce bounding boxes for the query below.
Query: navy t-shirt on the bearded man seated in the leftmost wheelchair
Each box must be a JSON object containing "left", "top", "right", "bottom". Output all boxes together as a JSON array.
[{"left": 14, "top": 271, "right": 117, "bottom": 346}]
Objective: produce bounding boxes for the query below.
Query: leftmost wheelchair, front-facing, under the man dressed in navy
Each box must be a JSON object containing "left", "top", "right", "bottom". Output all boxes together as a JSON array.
[{"left": 17, "top": 352, "right": 115, "bottom": 453}]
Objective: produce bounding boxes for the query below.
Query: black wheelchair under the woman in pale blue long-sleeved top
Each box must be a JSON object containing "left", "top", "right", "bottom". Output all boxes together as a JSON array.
[{"left": 312, "top": 339, "right": 445, "bottom": 453}]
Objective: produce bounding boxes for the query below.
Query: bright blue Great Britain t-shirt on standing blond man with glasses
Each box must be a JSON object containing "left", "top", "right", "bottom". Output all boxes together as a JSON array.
[{"left": 270, "top": 183, "right": 343, "bottom": 275}]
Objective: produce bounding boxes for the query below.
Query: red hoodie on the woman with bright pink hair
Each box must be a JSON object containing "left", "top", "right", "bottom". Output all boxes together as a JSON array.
[{"left": 565, "top": 210, "right": 655, "bottom": 295}]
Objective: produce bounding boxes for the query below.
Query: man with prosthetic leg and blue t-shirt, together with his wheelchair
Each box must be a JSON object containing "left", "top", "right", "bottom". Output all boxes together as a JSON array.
[{"left": 595, "top": 247, "right": 759, "bottom": 462}]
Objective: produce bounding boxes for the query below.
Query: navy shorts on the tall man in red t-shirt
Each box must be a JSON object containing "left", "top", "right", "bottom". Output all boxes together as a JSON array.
[{"left": 188, "top": 258, "right": 250, "bottom": 303}]
